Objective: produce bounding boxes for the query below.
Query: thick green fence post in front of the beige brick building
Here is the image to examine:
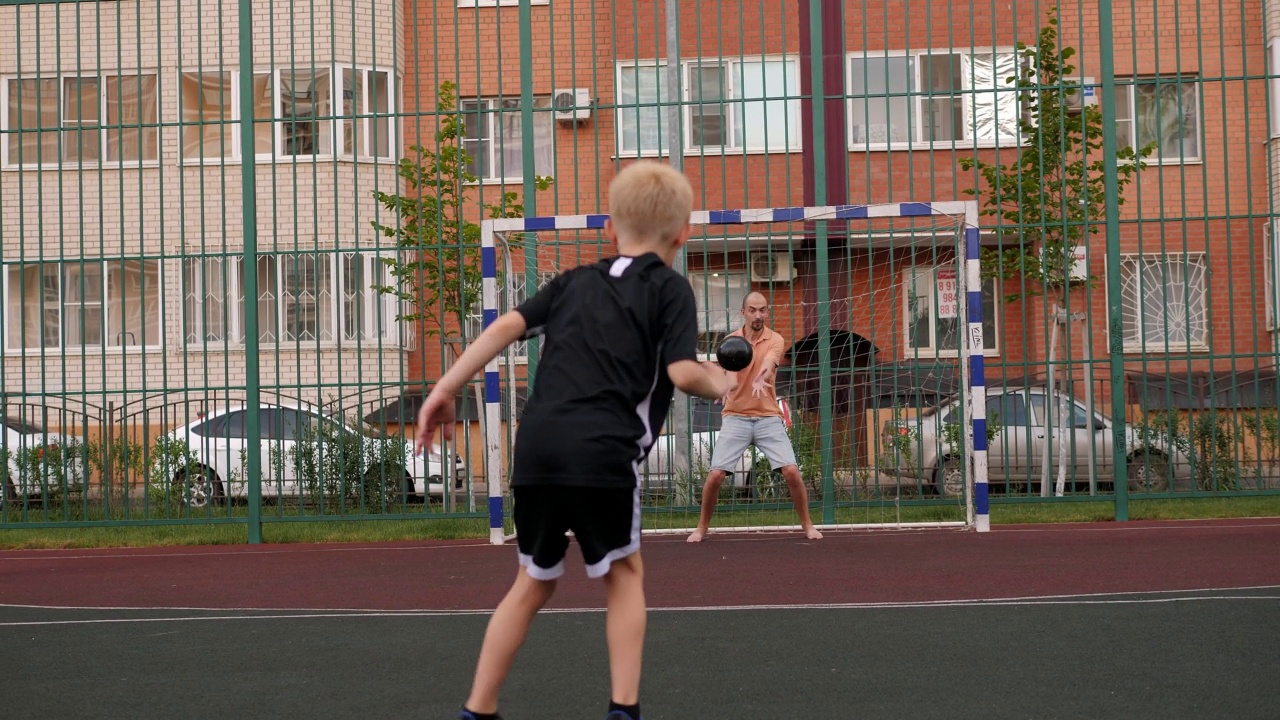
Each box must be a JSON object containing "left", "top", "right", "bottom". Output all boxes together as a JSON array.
[{"left": 239, "top": 0, "right": 262, "bottom": 544}]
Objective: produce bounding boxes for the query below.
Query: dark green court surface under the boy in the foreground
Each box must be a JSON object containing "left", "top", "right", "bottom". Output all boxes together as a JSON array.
[{"left": 0, "top": 587, "right": 1280, "bottom": 720}]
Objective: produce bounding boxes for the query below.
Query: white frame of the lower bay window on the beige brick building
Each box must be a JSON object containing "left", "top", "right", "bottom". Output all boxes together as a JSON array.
[{"left": 178, "top": 249, "right": 410, "bottom": 350}]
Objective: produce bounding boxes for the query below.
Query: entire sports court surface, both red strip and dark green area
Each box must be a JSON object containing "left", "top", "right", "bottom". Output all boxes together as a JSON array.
[{"left": 0, "top": 519, "right": 1280, "bottom": 720}]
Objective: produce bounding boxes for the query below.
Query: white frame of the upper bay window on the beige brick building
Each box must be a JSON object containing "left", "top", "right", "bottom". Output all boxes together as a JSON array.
[{"left": 177, "top": 63, "right": 402, "bottom": 165}]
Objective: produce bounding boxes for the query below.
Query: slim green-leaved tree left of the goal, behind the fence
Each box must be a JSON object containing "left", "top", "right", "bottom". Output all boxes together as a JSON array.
[{"left": 370, "top": 82, "right": 552, "bottom": 351}]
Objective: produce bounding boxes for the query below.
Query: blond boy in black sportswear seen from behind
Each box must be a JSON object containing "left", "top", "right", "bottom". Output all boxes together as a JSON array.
[{"left": 416, "top": 161, "right": 736, "bottom": 720}]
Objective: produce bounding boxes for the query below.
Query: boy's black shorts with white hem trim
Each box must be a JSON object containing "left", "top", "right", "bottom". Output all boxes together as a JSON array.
[{"left": 511, "top": 486, "right": 640, "bottom": 580}]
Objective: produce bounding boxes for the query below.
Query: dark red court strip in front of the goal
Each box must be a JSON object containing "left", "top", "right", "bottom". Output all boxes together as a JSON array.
[{"left": 0, "top": 519, "right": 1280, "bottom": 611}]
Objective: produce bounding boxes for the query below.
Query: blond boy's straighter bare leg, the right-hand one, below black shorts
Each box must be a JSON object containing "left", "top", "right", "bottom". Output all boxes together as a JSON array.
[{"left": 604, "top": 552, "right": 648, "bottom": 705}]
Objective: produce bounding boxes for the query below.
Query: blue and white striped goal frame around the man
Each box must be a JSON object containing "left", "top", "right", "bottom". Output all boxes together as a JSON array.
[{"left": 480, "top": 201, "right": 991, "bottom": 544}]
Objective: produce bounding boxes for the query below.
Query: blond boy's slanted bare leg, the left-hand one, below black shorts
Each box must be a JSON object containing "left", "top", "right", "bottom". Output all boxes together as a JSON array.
[{"left": 467, "top": 568, "right": 556, "bottom": 714}]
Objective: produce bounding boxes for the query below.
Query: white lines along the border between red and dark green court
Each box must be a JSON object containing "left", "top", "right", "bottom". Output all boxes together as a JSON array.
[{"left": 0, "top": 585, "right": 1280, "bottom": 628}]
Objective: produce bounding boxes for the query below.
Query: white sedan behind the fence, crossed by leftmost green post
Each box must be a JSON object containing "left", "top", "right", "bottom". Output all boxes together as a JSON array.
[{"left": 159, "top": 404, "right": 466, "bottom": 507}]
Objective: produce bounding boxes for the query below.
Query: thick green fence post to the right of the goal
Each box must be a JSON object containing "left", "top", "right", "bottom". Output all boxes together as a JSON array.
[{"left": 1085, "top": 0, "right": 1129, "bottom": 520}]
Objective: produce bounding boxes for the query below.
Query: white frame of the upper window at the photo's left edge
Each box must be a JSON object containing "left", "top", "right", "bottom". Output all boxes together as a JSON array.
[{"left": 0, "top": 69, "right": 164, "bottom": 170}]
